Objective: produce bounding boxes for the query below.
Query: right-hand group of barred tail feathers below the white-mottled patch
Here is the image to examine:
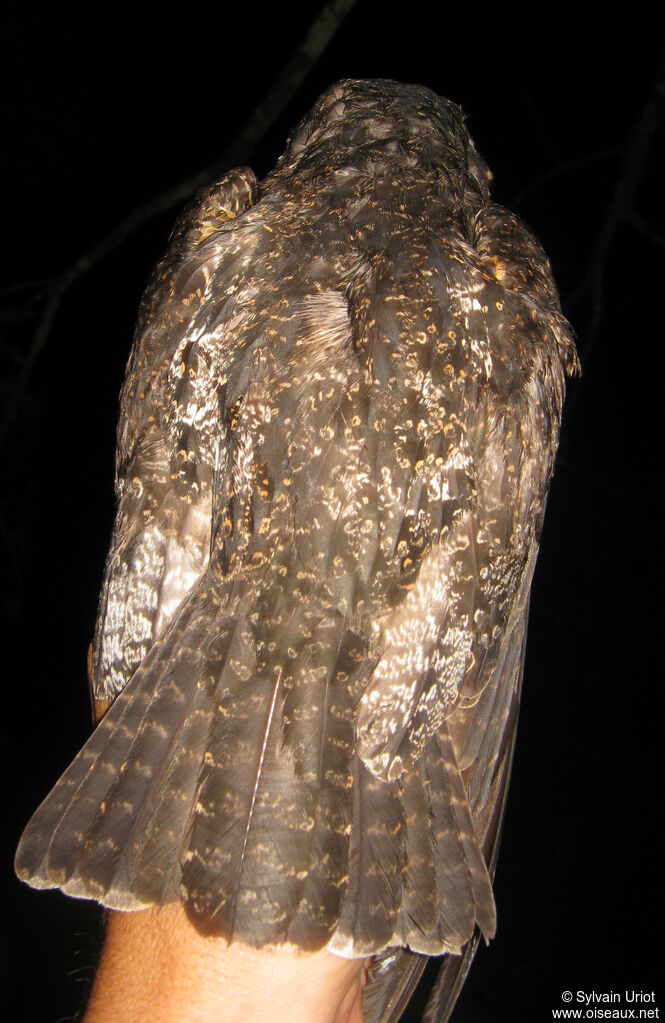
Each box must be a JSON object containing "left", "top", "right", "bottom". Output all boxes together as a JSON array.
[{"left": 328, "top": 729, "right": 495, "bottom": 955}]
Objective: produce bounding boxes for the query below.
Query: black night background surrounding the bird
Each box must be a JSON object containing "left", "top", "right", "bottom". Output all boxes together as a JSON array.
[{"left": 0, "top": 0, "right": 665, "bottom": 1023}]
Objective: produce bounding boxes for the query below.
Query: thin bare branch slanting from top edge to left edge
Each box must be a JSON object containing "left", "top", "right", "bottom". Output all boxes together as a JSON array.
[{"left": 0, "top": 0, "right": 355, "bottom": 442}]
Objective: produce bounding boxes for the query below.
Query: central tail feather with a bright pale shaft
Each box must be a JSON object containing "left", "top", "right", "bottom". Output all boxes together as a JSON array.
[{"left": 182, "top": 672, "right": 298, "bottom": 944}]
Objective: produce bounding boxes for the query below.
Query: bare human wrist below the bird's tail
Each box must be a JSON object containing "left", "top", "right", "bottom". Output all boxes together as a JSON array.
[{"left": 83, "top": 905, "right": 367, "bottom": 1023}]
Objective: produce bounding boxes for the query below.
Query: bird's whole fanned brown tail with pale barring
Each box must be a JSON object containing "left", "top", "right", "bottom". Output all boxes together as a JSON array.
[{"left": 15, "top": 586, "right": 495, "bottom": 957}]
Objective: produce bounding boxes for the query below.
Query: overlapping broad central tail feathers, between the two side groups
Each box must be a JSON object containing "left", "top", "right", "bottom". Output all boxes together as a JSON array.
[{"left": 182, "top": 605, "right": 361, "bottom": 948}]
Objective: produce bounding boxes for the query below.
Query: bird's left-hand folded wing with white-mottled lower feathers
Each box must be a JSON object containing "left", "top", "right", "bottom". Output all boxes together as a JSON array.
[{"left": 91, "top": 168, "right": 257, "bottom": 703}]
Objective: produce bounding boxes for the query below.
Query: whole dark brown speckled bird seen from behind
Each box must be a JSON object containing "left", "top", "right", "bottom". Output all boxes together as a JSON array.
[{"left": 16, "top": 81, "right": 578, "bottom": 1020}]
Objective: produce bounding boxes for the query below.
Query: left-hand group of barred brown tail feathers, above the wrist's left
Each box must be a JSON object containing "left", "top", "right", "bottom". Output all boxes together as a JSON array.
[{"left": 16, "top": 589, "right": 214, "bottom": 909}]
